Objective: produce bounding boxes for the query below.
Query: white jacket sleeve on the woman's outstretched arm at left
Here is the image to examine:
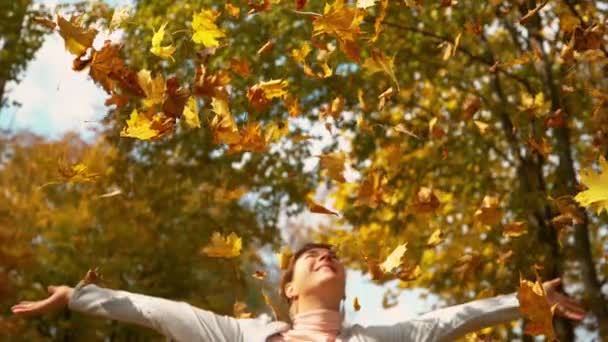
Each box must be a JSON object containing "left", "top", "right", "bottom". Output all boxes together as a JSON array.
[{"left": 68, "top": 282, "right": 251, "bottom": 342}]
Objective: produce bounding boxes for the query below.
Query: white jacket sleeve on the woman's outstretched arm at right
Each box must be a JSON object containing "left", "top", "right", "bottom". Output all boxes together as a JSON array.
[{"left": 365, "top": 292, "right": 521, "bottom": 342}]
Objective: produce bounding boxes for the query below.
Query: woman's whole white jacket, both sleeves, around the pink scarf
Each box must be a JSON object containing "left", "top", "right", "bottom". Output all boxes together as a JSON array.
[{"left": 68, "top": 281, "right": 521, "bottom": 342}]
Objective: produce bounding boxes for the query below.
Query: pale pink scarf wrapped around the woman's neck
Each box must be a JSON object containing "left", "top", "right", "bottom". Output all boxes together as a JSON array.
[{"left": 268, "top": 309, "right": 342, "bottom": 342}]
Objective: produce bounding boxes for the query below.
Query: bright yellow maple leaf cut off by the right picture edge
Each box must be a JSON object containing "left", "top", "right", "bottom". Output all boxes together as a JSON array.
[{"left": 574, "top": 156, "right": 608, "bottom": 215}]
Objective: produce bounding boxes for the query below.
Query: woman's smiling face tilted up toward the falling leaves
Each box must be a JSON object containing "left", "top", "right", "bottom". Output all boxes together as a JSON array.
[{"left": 286, "top": 248, "right": 346, "bottom": 301}]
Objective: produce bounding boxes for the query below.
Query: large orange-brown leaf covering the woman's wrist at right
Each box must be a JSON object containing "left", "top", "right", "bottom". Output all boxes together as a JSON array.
[{"left": 517, "top": 269, "right": 557, "bottom": 341}]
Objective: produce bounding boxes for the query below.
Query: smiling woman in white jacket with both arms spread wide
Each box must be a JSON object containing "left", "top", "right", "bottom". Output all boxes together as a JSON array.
[{"left": 12, "top": 243, "right": 585, "bottom": 342}]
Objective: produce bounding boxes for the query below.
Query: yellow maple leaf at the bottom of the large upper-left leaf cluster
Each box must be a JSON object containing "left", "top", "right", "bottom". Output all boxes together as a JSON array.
[{"left": 120, "top": 109, "right": 173, "bottom": 140}]
